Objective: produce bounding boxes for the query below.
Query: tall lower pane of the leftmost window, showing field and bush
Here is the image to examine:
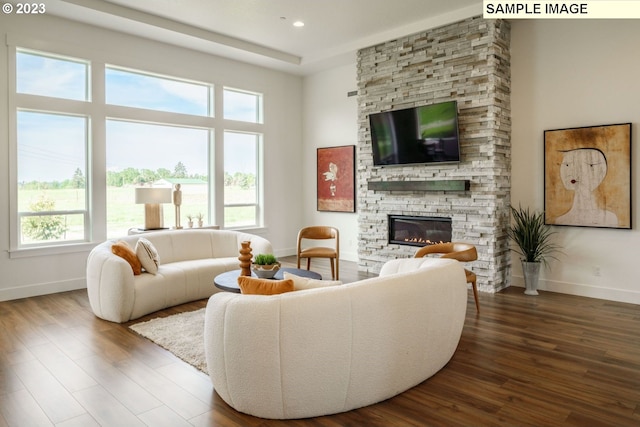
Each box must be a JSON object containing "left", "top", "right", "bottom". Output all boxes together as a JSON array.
[{"left": 17, "top": 111, "right": 88, "bottom": 245}]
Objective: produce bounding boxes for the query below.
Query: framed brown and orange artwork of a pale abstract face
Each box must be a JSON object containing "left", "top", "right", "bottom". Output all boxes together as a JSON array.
[{"left": 544, "top": 123, "right": 631, "bottom": 229}]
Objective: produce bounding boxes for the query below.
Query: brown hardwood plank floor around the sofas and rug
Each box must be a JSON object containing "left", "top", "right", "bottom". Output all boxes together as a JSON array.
[{"left": 0, "top": 257, "right": 640, "bottom": 427}]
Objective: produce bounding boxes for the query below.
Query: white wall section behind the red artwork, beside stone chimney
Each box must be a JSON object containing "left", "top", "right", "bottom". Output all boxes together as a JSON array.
[{"left": 301, "top": 65, "right": 358, "bottom": 261}]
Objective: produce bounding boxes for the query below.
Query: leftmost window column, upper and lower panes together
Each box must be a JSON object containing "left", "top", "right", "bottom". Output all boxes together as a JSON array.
[{"left": 14, "top": 49, "right": 90, "bottom": 247}]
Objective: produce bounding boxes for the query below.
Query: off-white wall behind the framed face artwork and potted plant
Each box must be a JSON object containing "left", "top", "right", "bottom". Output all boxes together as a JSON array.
[{"left": 511, "top": 20, "right": 640, "bottom": 304}]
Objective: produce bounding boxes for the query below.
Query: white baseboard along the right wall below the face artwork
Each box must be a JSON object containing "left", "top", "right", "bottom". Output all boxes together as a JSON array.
[{"left": 511, "top": 276, "right": 640, "bottom": 304}]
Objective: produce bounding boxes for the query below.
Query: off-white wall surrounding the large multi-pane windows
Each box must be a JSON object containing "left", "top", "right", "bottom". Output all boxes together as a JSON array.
[{"left": 0, "top": 14, "right": 304, "bottom": 300}]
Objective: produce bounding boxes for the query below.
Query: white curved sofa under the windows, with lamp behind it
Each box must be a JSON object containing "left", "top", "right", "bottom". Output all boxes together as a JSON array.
[{"left": 87, "top": 229, "right": 273, "bottom": 323}]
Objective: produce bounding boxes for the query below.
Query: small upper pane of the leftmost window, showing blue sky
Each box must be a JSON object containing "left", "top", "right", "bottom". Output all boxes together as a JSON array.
[{"left": 16, "top": 50, "right": 89, "bottom": 101}]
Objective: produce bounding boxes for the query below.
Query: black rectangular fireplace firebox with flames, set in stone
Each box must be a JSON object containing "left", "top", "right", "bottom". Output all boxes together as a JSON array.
[{"left": 388, "top": 215, "right": 451, "bottom": 246}]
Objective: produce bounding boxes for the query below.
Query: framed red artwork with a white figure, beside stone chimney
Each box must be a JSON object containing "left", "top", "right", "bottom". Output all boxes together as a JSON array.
[{"left": 316, "top": 145, "right": 356, "bottom": 212}]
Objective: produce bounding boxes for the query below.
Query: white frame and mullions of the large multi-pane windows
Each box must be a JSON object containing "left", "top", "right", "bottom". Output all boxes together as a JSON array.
[{"left": 6, "top": 38, "right": 266, "bottom": 258}]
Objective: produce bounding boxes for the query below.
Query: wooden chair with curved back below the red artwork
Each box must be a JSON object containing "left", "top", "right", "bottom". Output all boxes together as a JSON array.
[{"left": 297, "top": 226, "right": 340, "bottom": 280}]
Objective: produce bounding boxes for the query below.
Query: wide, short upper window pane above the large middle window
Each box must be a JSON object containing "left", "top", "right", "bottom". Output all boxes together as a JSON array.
[{"left": 105, "top": 67, "right": 212, "bottom": 116}]
